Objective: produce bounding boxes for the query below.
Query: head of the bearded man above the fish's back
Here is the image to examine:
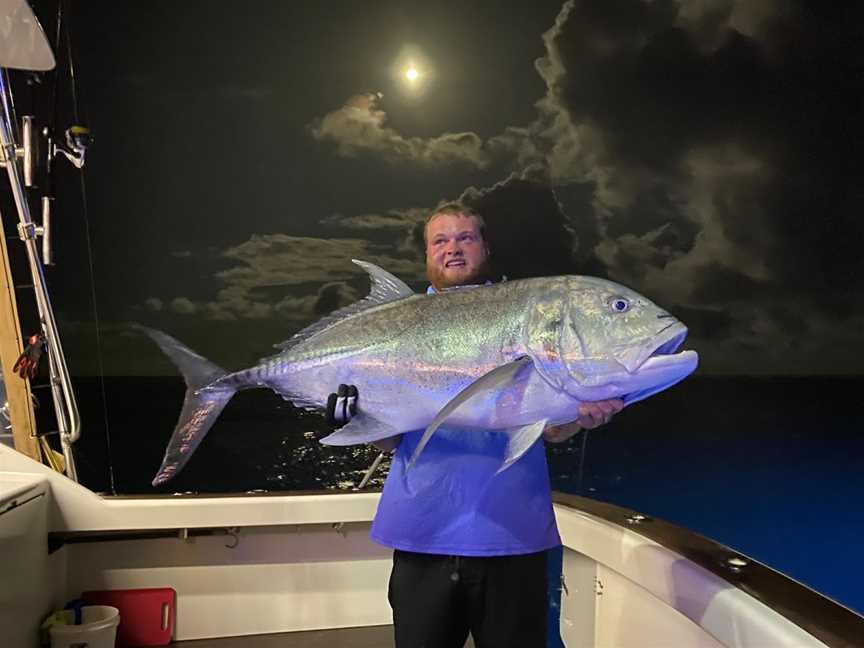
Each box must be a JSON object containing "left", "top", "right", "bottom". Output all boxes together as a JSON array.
[{"left": 426, "top": 214, "right": 489, "bottom": 290}]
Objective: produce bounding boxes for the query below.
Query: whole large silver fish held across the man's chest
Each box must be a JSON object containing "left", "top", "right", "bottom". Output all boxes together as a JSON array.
[{"left": 143, "top": 261, "right": 698, "bottom": 485}]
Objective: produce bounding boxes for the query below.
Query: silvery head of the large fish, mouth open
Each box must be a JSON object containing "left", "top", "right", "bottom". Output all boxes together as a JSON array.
[{"left": 544, "top": 277, "right": 698, "bottom": 404}]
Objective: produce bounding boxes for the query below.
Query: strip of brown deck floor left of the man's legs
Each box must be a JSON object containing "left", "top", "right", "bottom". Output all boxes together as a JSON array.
[{"left": 169, "top": 625, "right": 474, "bottom": 648}]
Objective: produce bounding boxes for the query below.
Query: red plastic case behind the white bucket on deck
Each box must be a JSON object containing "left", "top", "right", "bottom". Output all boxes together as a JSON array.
[{"left": 81, "top": 587, "right": 177, "bottom": 648}]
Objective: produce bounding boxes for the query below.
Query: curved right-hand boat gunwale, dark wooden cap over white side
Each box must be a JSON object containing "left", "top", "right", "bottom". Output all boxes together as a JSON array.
[{"left": 553, "top": 492, "right": 864, "bottom": 648}]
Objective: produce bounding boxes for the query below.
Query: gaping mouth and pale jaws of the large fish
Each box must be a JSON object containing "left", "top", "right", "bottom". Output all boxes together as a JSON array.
[{"left": 623, "top": 322, "right": 699, "bottom": 405}]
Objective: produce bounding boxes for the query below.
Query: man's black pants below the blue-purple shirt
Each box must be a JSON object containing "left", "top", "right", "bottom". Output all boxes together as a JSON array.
[{"left": 388, "top": 549, "right": 548, "bottom": 648}]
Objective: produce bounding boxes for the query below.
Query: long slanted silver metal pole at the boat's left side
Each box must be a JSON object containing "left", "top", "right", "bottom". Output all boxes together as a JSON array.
[{"left": 0, "top": 69, "right": 81, "bottom": 481}]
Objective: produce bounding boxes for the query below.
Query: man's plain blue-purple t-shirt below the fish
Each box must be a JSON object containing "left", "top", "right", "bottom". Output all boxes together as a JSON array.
[{"left": 369, "top": 282, "right": 561, "bottom": 556}]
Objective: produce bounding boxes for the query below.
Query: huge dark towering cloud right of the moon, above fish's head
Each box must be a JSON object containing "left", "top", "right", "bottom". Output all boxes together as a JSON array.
[{"left": 520, "top": 0, "right": 864, "bottom": 374}]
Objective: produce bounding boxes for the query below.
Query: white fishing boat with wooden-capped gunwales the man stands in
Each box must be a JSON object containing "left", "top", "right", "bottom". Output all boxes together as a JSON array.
[{"left": 0, "top": 0, "right": 864, "bottom": 648}]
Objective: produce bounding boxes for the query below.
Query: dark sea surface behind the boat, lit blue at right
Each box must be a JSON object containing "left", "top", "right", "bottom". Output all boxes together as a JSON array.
[{"left": 62, "top": 376, "right": 864, "bottom": 613}]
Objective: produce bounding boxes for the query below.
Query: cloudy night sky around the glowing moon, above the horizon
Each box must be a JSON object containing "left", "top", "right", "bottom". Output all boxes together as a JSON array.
[{"left": 19, "top": 0, "right": 864, "bottom": 375}]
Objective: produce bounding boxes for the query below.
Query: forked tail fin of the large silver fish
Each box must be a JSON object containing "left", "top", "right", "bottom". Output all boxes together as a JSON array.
[{"left": 134, "top": 325, "right": 243, "bottom": 486}]
